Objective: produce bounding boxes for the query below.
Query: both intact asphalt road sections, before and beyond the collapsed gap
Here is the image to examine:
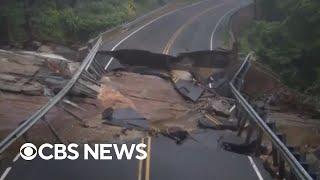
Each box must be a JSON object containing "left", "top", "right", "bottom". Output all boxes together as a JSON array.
[{"left": 0, "top": 0, "right": 271, "bottom": 180}]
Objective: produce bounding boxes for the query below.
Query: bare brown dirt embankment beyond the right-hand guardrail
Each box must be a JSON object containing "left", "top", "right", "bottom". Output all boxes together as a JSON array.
[{"left": 231, "top": 5, "right": 320, "bottom": 152}]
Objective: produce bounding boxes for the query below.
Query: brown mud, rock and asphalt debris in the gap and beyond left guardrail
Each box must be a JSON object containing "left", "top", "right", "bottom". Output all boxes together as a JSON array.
[{"left": 0, "top": 47, "right": 240, "bottom": 148}]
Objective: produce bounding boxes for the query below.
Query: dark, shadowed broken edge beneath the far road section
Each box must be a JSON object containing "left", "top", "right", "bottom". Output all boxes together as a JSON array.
[{"left": 98, "top": 49, "right": 232, "bottom": 70}]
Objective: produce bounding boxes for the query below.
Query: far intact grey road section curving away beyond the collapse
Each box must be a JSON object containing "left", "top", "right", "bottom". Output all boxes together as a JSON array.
[{"left": 101, "top": 0, "right": 242, "bottom": 55}]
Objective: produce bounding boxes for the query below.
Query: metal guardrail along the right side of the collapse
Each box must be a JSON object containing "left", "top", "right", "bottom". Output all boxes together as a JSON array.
[{"left": 229, "top": 53, "right": 312, "bottom": 180}]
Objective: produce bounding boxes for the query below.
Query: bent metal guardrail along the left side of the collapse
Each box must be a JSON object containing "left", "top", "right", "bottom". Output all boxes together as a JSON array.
[{"left": 0, "top": 37, "right": 102, "bottom": 154}]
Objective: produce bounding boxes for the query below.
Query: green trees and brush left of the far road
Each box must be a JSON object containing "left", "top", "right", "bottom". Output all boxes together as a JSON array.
[{"left": 0, "top": 0, "right": 170, "bottom": 48}]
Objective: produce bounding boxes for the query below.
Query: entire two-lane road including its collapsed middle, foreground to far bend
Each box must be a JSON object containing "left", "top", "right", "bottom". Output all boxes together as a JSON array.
[{"left": 0, "top": 0, "right": 276, "bottom": 180}]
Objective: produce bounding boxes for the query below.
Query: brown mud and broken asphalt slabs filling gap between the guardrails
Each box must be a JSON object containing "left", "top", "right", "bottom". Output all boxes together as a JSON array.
[{"left": 98, "top": 50, "right": 239, "bottom": 134}]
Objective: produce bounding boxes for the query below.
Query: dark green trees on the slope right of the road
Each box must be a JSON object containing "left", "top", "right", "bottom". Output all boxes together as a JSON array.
[{"left": 240, "top": 0, "right": 320, "bottom": 98}]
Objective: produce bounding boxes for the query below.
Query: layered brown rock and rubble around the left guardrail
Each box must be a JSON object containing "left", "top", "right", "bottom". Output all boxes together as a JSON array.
[{"left": 0, "top": 50, "right": 100, "bottom": 139}]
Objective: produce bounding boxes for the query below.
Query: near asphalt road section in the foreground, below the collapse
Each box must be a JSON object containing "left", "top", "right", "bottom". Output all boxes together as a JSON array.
[{"left": 5, "top": 130, "right": 271, "bottom": 180}]
